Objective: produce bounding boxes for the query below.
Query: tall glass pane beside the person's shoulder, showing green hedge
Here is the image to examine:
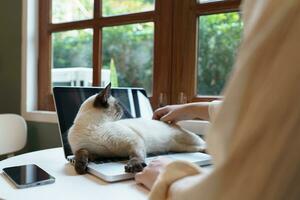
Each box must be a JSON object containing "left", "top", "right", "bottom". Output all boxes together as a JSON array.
[{"left": 197, "top": 12, "right": 243, "bottom": 95}]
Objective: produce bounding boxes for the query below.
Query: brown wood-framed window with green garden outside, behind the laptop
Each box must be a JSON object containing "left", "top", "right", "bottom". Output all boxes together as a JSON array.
[{"left": 38, "top": 0, "right": 242, "bottom": 110}]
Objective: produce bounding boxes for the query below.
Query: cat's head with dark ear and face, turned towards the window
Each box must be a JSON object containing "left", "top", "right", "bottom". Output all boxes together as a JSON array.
[{"left": 78, "top": 83, "right": 123, "bottom": 121}]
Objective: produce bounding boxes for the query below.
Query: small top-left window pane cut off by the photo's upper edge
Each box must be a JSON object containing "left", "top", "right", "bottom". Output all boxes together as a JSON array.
[{"left": 52, "top": 0, "right": 94, "bottom": 23}]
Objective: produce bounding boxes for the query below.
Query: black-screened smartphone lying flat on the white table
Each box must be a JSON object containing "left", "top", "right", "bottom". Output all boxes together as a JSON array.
[{"left": 3, "top": 164, "right": 55, "bottom": 188}]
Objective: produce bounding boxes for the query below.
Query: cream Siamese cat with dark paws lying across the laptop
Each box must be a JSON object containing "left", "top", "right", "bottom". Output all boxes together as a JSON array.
[{"left": 68, "top": 84, "right": 205, "bottom": 174}]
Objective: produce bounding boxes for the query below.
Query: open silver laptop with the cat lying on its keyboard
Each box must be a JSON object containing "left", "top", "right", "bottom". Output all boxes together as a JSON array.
[{"left": 53, "top": 87, "right": 211, "bottom": 182}]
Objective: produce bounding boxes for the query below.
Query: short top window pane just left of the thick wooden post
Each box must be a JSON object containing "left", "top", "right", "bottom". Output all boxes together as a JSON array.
[{"left": 102, "top": 0, "right": 155, "bottom": 16}]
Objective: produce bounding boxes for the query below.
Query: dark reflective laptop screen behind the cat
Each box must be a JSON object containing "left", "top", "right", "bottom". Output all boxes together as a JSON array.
[{"left": 53, "top": 87, "right": 153, "bottom": 158}]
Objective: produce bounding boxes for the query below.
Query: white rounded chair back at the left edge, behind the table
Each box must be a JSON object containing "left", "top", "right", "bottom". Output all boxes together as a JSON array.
[{"left": 0, "top": 114, "right": 27, "bottom": 157}]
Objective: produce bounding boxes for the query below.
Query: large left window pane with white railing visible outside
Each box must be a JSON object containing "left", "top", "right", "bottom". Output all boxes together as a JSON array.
[{"left": 52, "top": 29, "right": 93, "bottom": 86}]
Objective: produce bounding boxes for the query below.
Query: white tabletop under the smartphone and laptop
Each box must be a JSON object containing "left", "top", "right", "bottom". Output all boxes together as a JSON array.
[{"left": 0, "top": 148, "right": 148, "bottom": 200}]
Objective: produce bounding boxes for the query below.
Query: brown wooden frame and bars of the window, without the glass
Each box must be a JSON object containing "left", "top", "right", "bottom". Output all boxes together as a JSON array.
[{"left": 38, "top": 0, "right": 241, "bottom": 110}]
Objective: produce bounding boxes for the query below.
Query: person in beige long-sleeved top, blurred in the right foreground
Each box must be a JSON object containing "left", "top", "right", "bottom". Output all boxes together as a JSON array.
[{"left": 136, "top": 0, "right": 300, "bottom": 200}]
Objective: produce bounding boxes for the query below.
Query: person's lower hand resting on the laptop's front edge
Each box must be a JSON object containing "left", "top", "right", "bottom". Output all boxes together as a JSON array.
[{"left": 135, "top": 158, "right": 172, "bottom": 190}]
